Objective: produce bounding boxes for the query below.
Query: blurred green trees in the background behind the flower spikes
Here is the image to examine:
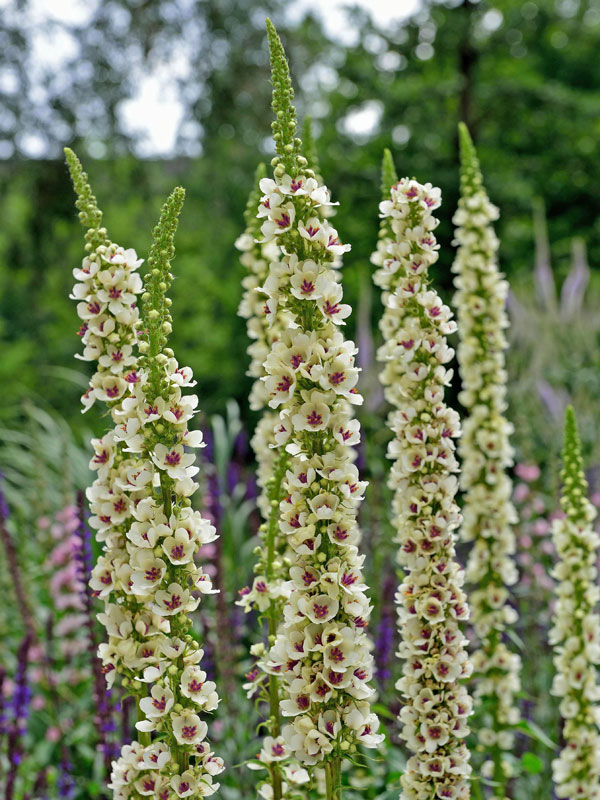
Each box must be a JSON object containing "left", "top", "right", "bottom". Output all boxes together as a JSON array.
[{"left": 0, "top": 0, "right": 600, "bottom": 466}]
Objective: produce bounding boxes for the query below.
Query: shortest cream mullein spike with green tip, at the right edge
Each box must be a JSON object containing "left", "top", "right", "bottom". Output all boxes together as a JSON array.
[{"left": 549, "top": 406, "right": 600, "bottom": 800}]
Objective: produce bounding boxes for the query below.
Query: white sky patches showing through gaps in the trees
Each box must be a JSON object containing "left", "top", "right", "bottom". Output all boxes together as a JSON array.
[{"left": 16, "top": 0, "right": 420, "bottom": 158}]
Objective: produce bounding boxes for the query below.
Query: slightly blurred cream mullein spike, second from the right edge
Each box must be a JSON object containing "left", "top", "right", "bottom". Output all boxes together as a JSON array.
[{"left": 453, "top": 123, "right": 521, "bottom": 798}]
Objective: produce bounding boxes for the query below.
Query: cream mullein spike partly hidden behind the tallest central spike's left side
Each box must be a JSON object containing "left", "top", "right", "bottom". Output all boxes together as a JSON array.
[{"left": 236, "top": 164, "right": 309, "bottom": 800}]
